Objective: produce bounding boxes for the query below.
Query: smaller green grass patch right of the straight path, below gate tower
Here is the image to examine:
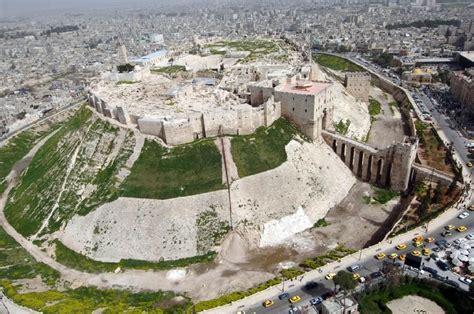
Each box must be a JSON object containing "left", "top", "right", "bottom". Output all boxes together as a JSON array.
[{"left": 232, "top": 118, "right": 304, "bottom": 178}]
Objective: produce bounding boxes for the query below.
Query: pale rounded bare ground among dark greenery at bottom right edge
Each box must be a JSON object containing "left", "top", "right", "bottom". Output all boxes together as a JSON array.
[{"left": 387, "top": 295, "right": 444, "bottom": 314}]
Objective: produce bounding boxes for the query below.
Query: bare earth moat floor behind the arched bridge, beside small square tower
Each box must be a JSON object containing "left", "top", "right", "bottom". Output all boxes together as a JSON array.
[{"left": 368, "top": 86, "right": 405, "bottom": 148}]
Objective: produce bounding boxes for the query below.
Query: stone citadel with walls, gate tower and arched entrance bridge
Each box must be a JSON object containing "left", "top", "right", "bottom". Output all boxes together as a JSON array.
[{"left": 88, "top": 46, "right": 427, "bottom": 191}]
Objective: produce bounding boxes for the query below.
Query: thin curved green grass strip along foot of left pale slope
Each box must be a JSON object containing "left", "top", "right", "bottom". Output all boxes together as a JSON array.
[{"left": 54, "top": 240, "right": 216, "bottom": 273}]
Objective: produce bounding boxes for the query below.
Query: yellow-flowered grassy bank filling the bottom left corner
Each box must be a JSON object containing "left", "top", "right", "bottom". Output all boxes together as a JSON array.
[{"left": 0, "top": 227, "right": 189, "bottom": 313}]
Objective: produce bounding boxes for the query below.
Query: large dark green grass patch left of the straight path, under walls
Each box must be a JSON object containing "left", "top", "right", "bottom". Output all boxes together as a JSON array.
[{"left": 121, "top": 139, "right": 224, "bottom": 199}]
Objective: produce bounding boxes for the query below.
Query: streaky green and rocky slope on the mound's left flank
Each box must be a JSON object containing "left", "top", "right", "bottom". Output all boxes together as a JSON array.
[{"left": 5, "top": 107, "right": 134, "bottom": 236}]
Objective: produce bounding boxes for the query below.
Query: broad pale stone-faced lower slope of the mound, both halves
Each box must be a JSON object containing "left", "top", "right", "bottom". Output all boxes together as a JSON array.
[{"left": 59, "top": 141, "right": 356, "bottom": 262}]
